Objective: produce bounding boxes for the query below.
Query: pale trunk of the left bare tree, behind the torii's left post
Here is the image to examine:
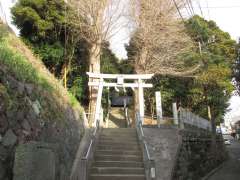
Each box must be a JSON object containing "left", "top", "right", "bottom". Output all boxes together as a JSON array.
[{"left": 89, "top": 42, "right": 101, "bottom": 126}]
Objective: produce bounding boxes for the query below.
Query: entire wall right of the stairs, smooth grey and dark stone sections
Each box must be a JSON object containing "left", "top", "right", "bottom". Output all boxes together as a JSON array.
[{"left": 144, "top": 127, "right": 227, "bottom": 180}]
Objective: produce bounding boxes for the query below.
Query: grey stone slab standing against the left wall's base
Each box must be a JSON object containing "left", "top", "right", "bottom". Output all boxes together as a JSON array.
[{"left": 13, "top": 142, "right": 56, "bottom": 180}]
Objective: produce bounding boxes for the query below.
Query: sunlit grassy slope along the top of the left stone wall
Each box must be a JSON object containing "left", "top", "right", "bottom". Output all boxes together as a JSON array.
[{"left": 0, "top": 24, "right": 82, "bottom": 121}]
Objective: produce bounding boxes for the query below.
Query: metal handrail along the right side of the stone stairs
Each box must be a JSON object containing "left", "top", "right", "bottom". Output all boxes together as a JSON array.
[{"left": 136, "top": 113, "right": 156, "bottom": 180}]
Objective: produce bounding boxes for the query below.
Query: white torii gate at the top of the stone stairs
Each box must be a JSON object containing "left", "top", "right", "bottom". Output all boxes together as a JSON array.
[{"left": 87, "top": 72, "right": 154, "bottom": 126}]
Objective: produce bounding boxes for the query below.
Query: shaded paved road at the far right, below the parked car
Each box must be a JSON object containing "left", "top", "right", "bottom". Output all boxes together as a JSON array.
[{"left": 208, "top": 142, "right": 240, "bottom": 180}]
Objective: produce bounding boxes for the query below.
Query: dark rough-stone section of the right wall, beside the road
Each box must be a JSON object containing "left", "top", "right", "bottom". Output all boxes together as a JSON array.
[{"left": 172, "top": 131, "right": 227, "bottom": 180}]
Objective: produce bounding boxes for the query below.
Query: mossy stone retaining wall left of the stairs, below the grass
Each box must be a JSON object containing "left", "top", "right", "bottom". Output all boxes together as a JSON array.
[{"left": 0, "top": 68, "right": 84, "bottom": 180}]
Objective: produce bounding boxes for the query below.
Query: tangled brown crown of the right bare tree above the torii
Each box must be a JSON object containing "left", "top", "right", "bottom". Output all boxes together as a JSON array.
[{"left": 128, "top": 0, "right": 200, "bottom": 75}]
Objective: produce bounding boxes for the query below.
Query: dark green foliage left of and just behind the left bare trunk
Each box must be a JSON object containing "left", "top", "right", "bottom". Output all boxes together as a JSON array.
[{"left": 12, "top": 0, "right": 126, "bottom": 105}]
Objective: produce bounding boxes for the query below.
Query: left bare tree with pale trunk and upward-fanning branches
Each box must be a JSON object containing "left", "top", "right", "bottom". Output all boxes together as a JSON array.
[{"left": 68, "top": 0, "right": 127, "bottom": 123}]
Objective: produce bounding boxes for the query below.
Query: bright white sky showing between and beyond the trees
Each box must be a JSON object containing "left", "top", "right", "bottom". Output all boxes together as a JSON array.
[{"left": 0, "top": 0, "right": 240, "bottom": 121}]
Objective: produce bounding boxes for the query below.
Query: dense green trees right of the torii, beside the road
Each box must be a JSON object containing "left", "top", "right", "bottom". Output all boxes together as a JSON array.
[{"left": 141, "top": 16, "right": 236, "bottom": 122}]
